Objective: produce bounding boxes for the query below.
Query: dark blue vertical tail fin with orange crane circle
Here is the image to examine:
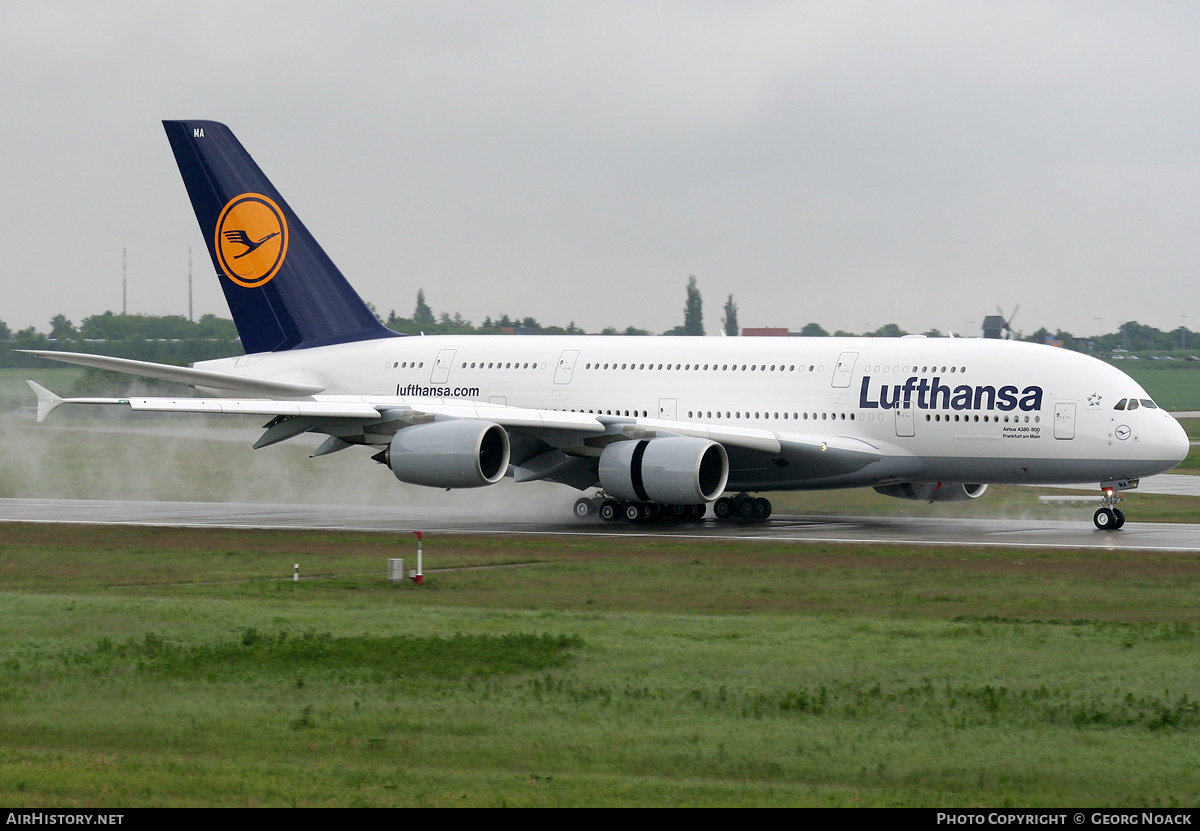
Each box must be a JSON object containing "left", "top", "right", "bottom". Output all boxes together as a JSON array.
[{"left": 163, "top": 121, "right": 397, "bottom": 353}]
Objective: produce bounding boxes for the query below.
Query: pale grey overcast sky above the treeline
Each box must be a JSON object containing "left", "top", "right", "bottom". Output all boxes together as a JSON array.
[{"left": 0, "top": 0, "right": 1200, "bottom": 335}]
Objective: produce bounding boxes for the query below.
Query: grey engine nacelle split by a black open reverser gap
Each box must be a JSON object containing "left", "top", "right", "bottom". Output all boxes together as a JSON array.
[{"left": 600, "top": 436, "right": 730, "bottom": 504}]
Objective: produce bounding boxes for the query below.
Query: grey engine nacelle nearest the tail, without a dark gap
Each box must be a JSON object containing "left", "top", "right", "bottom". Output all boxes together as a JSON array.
[{"left": 382, "top": 419, "right": 509, "bottom": 488}]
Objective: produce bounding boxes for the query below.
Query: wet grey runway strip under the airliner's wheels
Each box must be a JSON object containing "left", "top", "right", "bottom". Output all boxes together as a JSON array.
[{"left": 0, "top": 498, "right": 1200, "bottom": 552}]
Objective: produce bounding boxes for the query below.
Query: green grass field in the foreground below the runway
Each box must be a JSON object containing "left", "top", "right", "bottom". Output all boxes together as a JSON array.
[{"left": 0, "top": 525, "right": 1200, "bottom": 807}]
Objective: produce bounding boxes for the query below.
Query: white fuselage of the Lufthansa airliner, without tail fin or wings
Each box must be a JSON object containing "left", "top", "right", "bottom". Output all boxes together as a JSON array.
[{"left": 197, "top": 335, "right": 1188, "bottom": 490}]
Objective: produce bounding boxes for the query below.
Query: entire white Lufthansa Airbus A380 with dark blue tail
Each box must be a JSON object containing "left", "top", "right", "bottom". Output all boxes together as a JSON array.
[{"left": 23, "top": 121, "right": 1188, "bottom": 528}]
